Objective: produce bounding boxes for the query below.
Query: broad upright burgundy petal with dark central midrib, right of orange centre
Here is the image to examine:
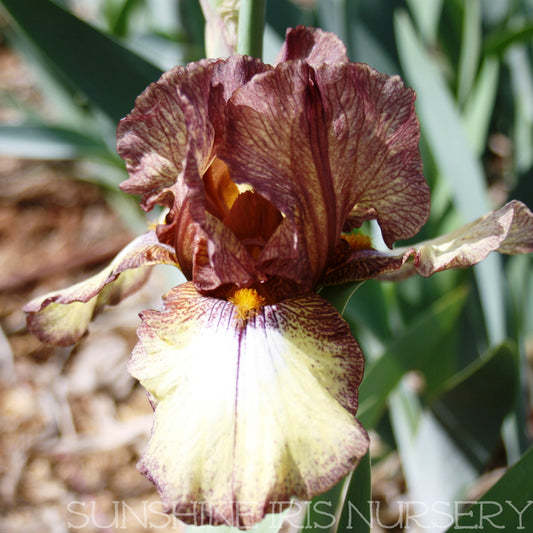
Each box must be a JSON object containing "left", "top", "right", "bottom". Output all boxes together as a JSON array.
[{"left": 219, "top": 61, "right": 429, "bottom": 287}]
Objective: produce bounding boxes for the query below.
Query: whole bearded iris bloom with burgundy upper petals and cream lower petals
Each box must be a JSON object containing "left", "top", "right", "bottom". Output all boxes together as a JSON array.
[{"left": 25, "top": 27, "right": 533, "bottom": 528}]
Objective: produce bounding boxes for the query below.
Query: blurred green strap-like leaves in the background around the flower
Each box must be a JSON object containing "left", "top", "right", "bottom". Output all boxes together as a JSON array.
[{"left": 0, "top": 0, "right": 533, "bottom": 531}]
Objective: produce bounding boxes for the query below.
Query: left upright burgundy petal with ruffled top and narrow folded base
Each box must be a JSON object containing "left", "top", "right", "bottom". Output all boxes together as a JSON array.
[{"left": 117, "top": 56, "right": 270, "bottom": 290}]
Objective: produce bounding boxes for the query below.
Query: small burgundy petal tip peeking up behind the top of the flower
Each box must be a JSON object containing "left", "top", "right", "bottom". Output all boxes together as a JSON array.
[{"left": 274, "top": 26, "right": 348, "bottom": 66}]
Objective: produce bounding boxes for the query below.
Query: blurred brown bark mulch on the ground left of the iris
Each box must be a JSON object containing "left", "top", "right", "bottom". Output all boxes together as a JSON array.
[{"left": 0, "top": 46, "right": 183, "bottom": 533}]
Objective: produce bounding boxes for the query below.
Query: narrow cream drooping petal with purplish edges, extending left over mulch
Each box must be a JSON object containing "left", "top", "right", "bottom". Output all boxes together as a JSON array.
[{"left": 24, "top": 232, "right": 178, "bottom": 346}]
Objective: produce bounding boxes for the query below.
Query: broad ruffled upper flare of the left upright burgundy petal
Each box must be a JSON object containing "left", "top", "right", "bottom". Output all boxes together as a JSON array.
[{"left": 117, "top": 56, "right": 268, "bottom": 209}]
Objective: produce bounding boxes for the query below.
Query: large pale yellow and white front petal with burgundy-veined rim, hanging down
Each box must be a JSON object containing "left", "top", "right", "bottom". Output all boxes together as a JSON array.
[{"left": 129, "top": 283, "right": 368, "bottom": 527}]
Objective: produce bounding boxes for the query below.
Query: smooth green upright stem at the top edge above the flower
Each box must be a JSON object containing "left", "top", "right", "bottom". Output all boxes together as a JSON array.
[{"left": 237, "top": 0, "right": 266, "bottom": 58}]
